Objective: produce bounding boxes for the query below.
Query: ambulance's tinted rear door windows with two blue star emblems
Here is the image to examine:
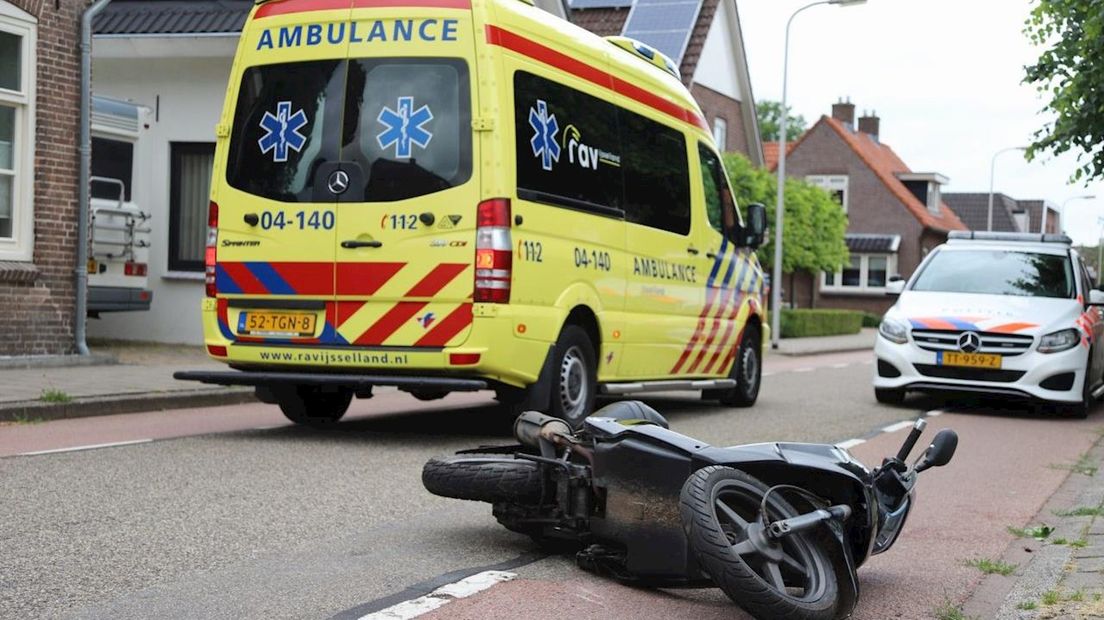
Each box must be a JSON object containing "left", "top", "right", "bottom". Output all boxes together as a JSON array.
[{"left": 226, "top": 58, "right": 471, "bottom": 202}]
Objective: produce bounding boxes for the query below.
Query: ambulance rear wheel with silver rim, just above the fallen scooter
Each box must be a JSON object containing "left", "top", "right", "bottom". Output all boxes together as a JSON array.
[{"left": 550, "top": 325, "right": 597, "bottom": 428}]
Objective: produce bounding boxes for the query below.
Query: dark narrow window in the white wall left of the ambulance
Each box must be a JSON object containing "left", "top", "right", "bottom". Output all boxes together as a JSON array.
[{"left": 169, "top": 142, "right": 214, "bottom": 271}]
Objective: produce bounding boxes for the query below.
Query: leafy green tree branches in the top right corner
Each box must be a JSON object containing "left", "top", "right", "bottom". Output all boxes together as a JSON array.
[{"left": 1023, "top": 0, "right": 1104, "bottom": 182}]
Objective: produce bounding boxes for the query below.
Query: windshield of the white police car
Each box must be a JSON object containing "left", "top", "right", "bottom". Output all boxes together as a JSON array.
[{"left": 912, "top": 249, "right": 1075, "bottom": 299}]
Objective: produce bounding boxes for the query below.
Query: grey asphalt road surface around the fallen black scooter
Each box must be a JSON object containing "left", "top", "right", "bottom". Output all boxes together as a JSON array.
[{"left": 0, "top": 352, "right": 1104, "bottom": 618}]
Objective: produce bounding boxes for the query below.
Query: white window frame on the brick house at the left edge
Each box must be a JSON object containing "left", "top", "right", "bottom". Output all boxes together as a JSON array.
[{"left": 0, "top": 7, "right": 38, "bottom": 263}]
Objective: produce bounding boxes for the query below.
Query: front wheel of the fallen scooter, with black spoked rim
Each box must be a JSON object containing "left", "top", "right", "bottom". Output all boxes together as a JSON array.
[{"left": 679, "top": 466, "right": 840, "bottom": 620}]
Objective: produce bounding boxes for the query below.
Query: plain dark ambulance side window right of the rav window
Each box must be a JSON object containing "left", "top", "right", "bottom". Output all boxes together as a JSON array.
[{"left": 618, "top": 108, "right": 690, "bottom": 235}]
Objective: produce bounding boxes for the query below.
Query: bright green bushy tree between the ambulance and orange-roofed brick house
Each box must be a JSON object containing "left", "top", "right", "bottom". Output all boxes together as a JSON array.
[{"left": 723, "top": 153, "right": 849, "bottom": 279}]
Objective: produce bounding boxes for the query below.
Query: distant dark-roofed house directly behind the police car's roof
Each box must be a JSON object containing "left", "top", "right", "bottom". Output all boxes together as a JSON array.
[{"left": 943, "top": 192, "right": 1062, "bottom": 233}]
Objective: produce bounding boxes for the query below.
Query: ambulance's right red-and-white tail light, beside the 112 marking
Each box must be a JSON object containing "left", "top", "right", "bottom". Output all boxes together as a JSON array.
[{"left": 474, "top": 199, "right": 513, "bottom": 303}]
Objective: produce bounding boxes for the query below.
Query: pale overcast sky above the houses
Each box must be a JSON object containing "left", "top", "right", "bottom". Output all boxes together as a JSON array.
[{"left": 736, "top": 0, "right": 1104, "bottom": 245}]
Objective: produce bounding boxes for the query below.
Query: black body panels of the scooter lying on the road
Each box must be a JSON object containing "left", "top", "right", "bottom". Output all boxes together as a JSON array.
[{"left": 586, "top": 417, "right": 878, "bottom": 605}]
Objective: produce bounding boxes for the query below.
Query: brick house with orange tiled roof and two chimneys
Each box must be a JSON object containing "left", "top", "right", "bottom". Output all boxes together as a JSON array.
[{"left": 764, "top": 101, "right": 966, "bottom": 313}]
